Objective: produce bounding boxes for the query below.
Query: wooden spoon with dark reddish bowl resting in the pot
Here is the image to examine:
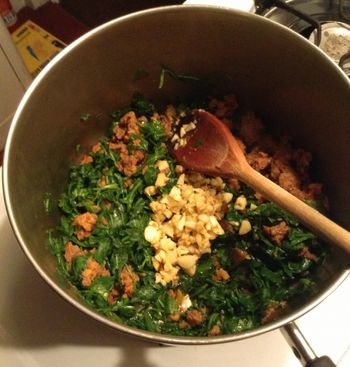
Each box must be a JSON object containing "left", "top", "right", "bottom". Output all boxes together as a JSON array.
[{"left": 170, "top": 110, "right": 350, "bottom": 252}]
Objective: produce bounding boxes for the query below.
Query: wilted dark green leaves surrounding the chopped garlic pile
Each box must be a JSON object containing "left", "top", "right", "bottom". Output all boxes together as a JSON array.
[{"left": 45, "top": 94, "right": 327, "bottom": 336}]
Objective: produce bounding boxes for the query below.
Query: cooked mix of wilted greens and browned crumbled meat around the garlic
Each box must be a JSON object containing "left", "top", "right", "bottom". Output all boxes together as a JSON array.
[{"left": 49, "top": 95, "right": 326, "bottom": 336}]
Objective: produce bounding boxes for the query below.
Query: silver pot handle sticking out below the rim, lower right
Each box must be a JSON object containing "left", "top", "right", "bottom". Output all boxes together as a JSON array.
[{"left": 281, "top": 322, "right": 336, "bottom": 367}]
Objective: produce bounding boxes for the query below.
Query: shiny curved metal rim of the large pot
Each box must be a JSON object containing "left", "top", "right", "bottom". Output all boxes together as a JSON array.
[{"left": 2, "top": 4, "right": 350, "bottom": 345}]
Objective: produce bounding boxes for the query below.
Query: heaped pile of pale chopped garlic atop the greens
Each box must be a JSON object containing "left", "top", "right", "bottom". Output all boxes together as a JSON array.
[{"left": 145, "top": 169, "right": 232, "bottom": 285}]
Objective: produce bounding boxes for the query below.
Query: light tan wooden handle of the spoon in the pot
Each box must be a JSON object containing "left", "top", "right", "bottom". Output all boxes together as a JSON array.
[{"left": 239, "top": 166, "right": 350, "bottom": 253}]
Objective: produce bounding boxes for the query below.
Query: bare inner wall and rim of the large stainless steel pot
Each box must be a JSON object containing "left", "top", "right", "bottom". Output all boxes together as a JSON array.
[{"left": 3, "top": 6, "right": 350, "bottom": 367}]
